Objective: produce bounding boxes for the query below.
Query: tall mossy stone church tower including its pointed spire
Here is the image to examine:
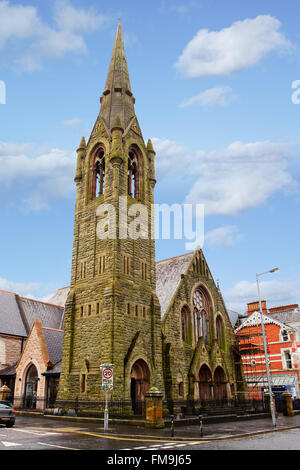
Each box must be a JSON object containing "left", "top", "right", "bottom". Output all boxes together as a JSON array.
[{"left": 57, "top": 22, "right": 164, "bottom": 410}]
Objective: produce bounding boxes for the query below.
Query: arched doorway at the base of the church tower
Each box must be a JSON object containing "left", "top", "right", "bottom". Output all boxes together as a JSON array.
[{"left": 130, "top": 359, "right": 150, "bottom": 414}]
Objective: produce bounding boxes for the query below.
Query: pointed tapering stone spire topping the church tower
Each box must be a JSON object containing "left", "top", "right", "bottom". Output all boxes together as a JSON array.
[{"left": 100, "top": 20, "right": 135, "bottom": 130}]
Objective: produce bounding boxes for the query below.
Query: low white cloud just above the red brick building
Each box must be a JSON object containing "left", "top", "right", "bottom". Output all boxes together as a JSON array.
[{"left": 223, "top": 280, "right": 300, "bottom": 313}]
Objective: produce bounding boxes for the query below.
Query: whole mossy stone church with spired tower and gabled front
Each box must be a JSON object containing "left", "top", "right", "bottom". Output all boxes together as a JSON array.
[{"left": 57, "top": 23, "right": 246, "bottom": 409}]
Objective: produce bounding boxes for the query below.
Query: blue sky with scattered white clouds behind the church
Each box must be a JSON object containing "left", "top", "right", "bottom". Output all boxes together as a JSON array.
[{"left": 0, "top": 0, "right": 300, "bottom": 311}]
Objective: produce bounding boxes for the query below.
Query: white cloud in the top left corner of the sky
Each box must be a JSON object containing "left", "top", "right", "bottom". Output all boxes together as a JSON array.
[{"left": 0, "top": 0, "right": 106, "bottom": 71}]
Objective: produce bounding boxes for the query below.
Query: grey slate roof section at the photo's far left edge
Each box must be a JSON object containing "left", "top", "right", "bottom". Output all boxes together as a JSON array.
[{"left": 0, "top": 291, "right": 28, "bottom": 337}]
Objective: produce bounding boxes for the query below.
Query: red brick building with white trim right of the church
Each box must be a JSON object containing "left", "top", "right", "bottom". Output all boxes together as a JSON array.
[{"left": 235, "top": 301, "right": 300, "bottom": 399}]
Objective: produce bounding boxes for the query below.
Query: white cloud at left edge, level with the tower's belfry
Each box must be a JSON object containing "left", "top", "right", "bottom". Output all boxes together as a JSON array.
[{"left": 0, "top": 142, "right": 76, "bottom": 212}]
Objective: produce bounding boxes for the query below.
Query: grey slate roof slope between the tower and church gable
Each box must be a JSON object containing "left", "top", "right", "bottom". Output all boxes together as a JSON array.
[{"left": 156, "top": 252, "right": 194, "bottom": 317}]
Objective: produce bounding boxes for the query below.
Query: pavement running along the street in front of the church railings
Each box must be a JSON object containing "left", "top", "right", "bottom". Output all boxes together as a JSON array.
[{"left": 16, "top": 411, "right": 300, "bottom": 442}]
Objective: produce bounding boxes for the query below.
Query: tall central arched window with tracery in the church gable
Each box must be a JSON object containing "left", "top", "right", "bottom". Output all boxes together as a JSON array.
[{"left": 193, "top": 287, "right": 211, "bottom": 344}]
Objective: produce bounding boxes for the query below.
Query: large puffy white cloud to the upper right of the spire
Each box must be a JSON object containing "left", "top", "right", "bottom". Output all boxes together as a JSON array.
[{"left": 175, "top": 15, "right": 292, "bottom": 78}]
